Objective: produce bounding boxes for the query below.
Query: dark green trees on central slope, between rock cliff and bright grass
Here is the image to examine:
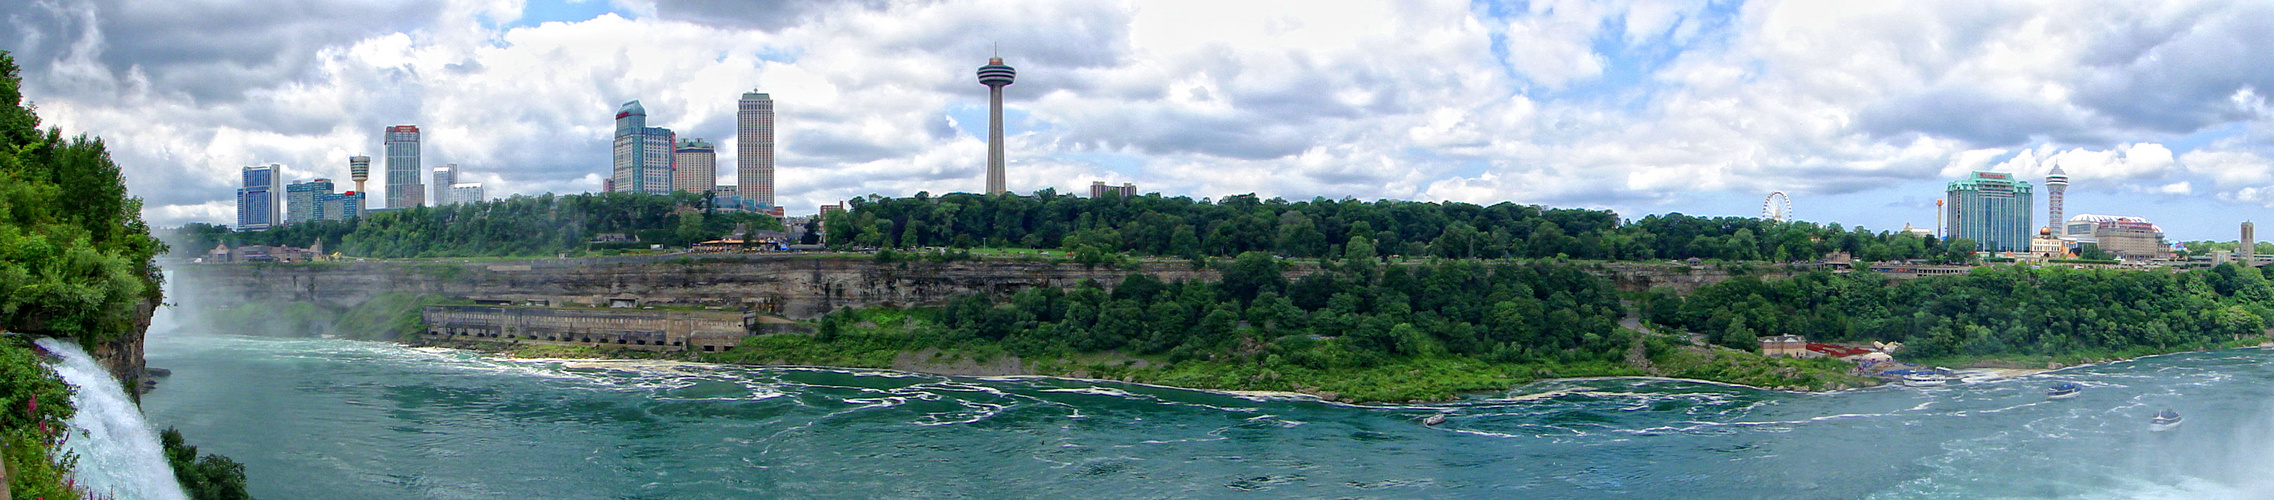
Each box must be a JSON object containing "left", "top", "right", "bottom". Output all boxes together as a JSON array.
[{"left": 914, "top": 245, "right": 1630, "bottom": 368}]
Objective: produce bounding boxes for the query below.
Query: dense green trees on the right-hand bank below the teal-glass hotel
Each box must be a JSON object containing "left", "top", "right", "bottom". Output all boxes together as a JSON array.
[{"left": 1644, "top": 264, "right": 2274, "bottom": 357}]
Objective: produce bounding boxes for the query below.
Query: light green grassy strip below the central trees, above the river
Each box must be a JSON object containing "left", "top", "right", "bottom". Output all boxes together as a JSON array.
[{"left": 700, "top": 309, "right": 1876, "bottom": 402}]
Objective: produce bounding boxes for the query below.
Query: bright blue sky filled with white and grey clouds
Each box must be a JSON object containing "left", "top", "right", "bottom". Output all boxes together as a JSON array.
[{"left": 0, "top": 0, "right": 2274, "bottom": 241}]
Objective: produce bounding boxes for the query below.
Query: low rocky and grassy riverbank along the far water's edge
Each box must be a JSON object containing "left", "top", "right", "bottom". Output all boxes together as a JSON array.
[{"left": 418, "top": 330, "right": 1876, "bottom": 405}]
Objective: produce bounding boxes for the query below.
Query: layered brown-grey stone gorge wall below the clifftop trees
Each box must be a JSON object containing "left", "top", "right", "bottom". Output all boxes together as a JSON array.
[{"left": 171, "top": 255, "right": 1790, "bottom": 318}]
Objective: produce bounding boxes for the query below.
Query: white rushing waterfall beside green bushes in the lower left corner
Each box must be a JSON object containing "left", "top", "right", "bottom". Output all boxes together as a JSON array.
[{"left": 39, "top": 339, "right": 189, "bottom": 500}]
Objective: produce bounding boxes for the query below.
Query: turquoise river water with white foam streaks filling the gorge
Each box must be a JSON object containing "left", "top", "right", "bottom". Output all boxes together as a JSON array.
[{"left": 143, "top": 322, "right": 2274, "bottom": 498}]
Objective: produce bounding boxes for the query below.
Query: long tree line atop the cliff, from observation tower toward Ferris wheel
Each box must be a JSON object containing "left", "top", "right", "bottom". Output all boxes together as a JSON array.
[{"left": 825, "top": 191, "right": 1974, "bottom": 261}]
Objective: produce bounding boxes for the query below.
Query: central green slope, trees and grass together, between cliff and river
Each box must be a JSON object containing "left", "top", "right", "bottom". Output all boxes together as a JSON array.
[{"left": 705, "top": 250, "right": 1869, "bottom": 402}]
